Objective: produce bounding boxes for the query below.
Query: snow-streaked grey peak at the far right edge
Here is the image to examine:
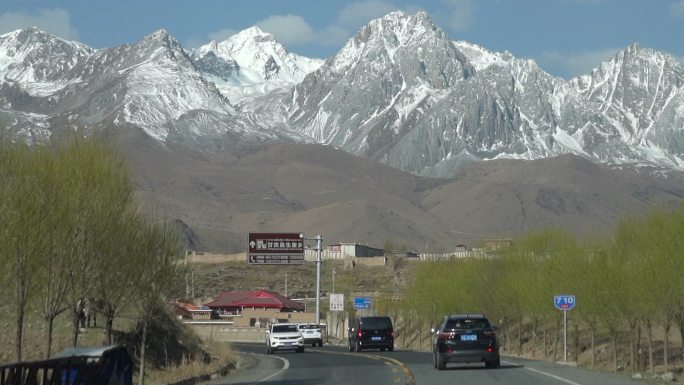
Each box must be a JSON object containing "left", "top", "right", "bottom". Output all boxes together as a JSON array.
[{"left": 570, "top": 44, "right": 684, "bottom": 165}]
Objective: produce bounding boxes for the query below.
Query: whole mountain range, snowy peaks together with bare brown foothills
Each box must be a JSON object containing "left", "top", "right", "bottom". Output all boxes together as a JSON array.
[{"left": 0, "top": 11, "right": 684, "bottom": 249}]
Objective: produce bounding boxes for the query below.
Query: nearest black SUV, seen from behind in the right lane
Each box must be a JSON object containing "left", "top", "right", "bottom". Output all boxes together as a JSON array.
[{"left": 432, "top": 314, "right": 501, "bottom": 370}]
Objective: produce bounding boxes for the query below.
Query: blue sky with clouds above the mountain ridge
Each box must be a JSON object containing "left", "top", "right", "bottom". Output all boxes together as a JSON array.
[{"left": 0, "top": 0, "right": 684, "bottom": 78}]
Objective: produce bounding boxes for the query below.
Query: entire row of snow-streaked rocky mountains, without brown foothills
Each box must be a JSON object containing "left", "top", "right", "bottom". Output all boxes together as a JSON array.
[{"left": 0, "top": 12, "right": 684, "bottom": 176}]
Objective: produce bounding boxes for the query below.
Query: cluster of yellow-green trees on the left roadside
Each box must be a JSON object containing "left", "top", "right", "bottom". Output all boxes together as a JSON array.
[{"left": 0, "top": 138, "right": 185, "bottom": 363}]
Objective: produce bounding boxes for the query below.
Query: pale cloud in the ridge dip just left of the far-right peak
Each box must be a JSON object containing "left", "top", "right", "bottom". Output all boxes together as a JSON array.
[{"left": 536, "top": 48, "right": 620, "bottom": 78}]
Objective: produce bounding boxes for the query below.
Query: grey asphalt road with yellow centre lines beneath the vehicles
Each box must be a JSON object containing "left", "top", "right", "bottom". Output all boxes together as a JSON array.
[{"left": 208, "top": 344, "right": 645, "bottom": 385}]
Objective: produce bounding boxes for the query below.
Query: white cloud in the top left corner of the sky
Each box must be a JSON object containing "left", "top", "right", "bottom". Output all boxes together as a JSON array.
[{"left": 0, "top": 8, "right": 78, "bottom": 40}]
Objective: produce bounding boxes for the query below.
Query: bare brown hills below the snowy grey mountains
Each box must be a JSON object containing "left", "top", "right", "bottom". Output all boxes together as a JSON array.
[{"left": 122, "top": 135, "right": 684, "bottom": 252}]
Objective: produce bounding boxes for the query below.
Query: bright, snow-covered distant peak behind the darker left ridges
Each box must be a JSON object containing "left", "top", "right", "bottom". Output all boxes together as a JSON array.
[{"left": 192, "top": 27, "right": 323, "bottom": 104}]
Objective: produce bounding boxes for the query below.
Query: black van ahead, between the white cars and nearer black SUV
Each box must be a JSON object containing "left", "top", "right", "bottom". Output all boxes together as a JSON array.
[{"left": 349, "top": 317, "right": 394, "bottom": 352}]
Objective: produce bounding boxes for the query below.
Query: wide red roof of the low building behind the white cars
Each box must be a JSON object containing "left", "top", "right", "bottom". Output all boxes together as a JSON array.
[{"left": 204, "top": 290, "right": 304, "bottom": 314}]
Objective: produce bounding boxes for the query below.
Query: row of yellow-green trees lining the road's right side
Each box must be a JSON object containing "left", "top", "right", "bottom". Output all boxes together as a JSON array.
[{"left": 380, "top": 208, "right": 684, "bottom": 371}]
